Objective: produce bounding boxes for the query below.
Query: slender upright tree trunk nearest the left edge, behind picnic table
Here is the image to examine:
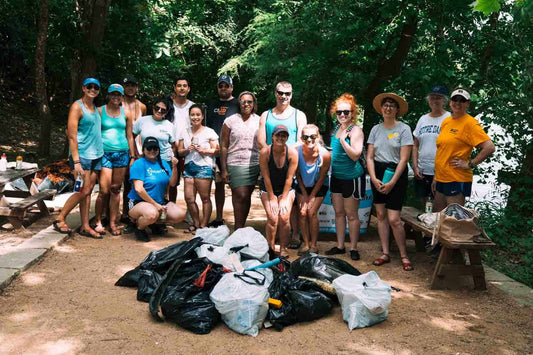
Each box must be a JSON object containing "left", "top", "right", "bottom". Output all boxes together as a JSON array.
[{"left": 34, "top": 0, "right": 52, "bottom": 157}]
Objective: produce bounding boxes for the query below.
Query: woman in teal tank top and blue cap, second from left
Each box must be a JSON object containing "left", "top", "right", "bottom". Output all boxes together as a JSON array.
[{"left": 94, "top": 84, "right": 135, "bottom": 235}]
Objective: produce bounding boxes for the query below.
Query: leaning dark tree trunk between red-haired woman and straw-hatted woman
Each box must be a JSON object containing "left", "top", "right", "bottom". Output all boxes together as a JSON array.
[{"left": 363, "top": 16, "right": 418, "bottom": 137}]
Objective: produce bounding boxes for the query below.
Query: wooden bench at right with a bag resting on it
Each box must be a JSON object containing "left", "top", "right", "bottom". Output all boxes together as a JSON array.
[{"left": 401, "top": 207, "right": 496, "bottom": 290}]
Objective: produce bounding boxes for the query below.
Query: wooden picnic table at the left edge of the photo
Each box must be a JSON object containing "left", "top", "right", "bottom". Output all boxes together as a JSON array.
[{"left": 0, "top": 168, "right": 56, "bottom": 229}]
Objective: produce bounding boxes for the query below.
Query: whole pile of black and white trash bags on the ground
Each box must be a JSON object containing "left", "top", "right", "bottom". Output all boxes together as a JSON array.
[{"left": 115, "top": 225, "right": 391, "bottom": 336}]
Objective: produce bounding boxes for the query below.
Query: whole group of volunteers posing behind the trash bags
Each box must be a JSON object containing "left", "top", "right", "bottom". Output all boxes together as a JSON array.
[{"left": 54, "top": 75, "right": 494, "bottom": 271}]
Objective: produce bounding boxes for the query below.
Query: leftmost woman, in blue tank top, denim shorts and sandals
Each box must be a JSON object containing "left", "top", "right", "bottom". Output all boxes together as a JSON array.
[{"left": 53, "top": 78, "right": 104, "bottom": 239}]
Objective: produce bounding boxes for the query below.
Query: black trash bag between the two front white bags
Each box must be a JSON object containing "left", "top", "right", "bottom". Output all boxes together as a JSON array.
[{"left": 267, "top": 272, "right": 333, "bottom": 330}]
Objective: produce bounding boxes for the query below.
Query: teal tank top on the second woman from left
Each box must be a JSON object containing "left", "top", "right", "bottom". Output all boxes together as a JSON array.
[{"left": 102, "top": 105, "right": 129, "bottom": 153}]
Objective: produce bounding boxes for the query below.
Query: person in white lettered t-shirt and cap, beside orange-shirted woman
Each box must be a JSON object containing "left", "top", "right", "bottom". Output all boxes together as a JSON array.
[{"left": 412, "top": 85, "right": 451, "bottom": 217}]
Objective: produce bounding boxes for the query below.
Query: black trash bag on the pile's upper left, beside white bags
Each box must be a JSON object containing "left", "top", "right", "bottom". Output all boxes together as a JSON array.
[{"left": 139, "top": 238, "right": 203, "bottom": 274}]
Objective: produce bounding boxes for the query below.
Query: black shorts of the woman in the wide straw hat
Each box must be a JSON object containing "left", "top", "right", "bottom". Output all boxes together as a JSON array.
[{"left": 372, "top": 161, "right": 408, "bottom": 211}]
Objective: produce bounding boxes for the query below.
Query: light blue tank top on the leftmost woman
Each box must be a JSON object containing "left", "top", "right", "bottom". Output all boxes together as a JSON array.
[{"left": 76, "top": 100, "right": 104, "bottom": 159}]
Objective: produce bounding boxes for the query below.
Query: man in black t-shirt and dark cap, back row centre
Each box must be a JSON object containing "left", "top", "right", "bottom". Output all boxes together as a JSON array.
[{"left": 205, "top": 75, "right": 239, "bottom": 227}]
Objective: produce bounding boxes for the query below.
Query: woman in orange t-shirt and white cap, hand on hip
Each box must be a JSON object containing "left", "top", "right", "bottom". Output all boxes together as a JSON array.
[{"left": 432, "top": 88, "right": 495, "bottom": 211}]
